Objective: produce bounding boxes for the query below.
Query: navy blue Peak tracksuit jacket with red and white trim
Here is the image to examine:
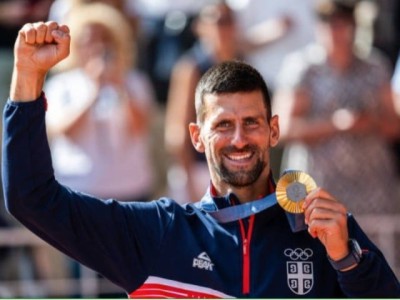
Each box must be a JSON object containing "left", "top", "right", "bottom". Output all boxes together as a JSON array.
[{"left": 2, "top": 97, "right": 400, "bottom": 298}]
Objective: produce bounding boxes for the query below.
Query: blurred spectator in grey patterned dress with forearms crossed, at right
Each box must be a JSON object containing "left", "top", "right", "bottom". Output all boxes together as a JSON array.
[{"left": 274, "top": 0, "right": 400, "bottom": 274}]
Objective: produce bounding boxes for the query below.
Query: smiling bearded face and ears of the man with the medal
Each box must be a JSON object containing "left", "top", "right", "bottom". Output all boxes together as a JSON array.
[{"left": 191, "top": 91, "right": 279, "bottom": 188}]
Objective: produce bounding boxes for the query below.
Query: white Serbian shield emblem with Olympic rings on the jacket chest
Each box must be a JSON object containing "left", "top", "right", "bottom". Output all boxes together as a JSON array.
[{"left": 283, "top": 248, "right": 314, "bottom": 295}]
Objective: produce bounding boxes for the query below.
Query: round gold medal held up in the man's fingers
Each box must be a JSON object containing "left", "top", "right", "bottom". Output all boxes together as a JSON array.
[{"left": 276, "top": 171, "right": 317, "bottom": 214}]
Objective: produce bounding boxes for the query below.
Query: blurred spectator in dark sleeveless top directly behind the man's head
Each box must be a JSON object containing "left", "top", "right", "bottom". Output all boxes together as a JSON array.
[{"left": 165, "top": 1, "right": 291, "bottom": 202}]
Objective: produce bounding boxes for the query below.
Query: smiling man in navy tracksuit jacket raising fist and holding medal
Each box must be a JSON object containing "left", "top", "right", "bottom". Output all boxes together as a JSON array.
[{"left": 3, "top": 22, "right": 400, "bottom": 298}]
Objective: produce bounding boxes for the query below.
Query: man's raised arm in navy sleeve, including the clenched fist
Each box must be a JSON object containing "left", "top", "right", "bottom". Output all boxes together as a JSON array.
[{"left": 2, "top": 22, "right": 170, "bottom": 292}]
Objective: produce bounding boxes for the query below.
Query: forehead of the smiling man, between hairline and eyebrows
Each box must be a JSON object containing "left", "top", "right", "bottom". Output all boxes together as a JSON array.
[{"left": 204, "top": 91, "right": 267, "bottom": 120}]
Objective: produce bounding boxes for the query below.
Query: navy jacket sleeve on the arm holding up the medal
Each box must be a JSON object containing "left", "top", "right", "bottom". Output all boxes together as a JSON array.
[{"left": 338, "top": 216, "right": 400, "bottom": 298}]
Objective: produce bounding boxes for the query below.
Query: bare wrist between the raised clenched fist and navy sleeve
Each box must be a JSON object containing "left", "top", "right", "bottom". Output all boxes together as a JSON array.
[{"left": 10, "top": 68, "right": 46, "bottom": 102}]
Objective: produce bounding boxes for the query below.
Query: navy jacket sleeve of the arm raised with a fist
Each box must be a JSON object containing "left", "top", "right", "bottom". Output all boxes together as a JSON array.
[{"left": 2, "top": 97, "right": 176, "bottom": 292}]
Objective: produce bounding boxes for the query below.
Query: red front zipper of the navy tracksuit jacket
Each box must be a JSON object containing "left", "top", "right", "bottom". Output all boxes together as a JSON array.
[{"left": 239, "top": 215, "right": 255, "bottom": 295}]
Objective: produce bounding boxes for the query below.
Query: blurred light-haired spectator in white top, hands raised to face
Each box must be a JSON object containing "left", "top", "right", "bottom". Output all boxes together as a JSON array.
[{"left": 46, "top": 3, "right": 154, "bottom": 201}]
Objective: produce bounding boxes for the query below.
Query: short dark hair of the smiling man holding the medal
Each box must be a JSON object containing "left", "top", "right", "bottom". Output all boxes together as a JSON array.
[{"left": 195, "top": 61, "right": 272, "bottom": 124}]
